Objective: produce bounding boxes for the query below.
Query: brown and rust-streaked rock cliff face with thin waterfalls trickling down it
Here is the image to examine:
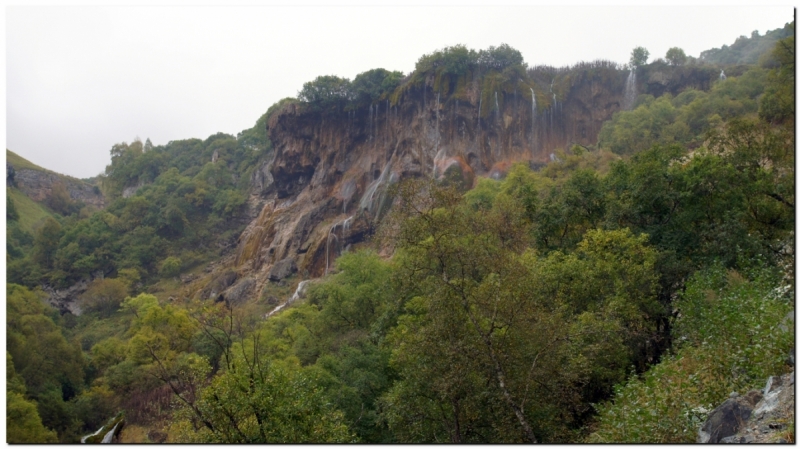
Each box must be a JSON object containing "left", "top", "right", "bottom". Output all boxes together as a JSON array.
[{"left": 230, "top": 62, "right": 656, "bottom": 285}]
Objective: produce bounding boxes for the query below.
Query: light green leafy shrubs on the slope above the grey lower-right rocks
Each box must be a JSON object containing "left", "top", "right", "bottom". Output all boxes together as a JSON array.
[{"left": 587, "top": 265, "right": 794, "bottom": 444}]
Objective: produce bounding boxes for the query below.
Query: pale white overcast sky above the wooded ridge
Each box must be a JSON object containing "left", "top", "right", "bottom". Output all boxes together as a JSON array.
[{"left": 5, "top": 6, "right": 794, "bottom": 178}]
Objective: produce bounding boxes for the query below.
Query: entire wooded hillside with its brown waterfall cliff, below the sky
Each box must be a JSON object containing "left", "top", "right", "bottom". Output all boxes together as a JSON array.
[{"left": 7, "top": 25, "right": 795, "bottom": 443}]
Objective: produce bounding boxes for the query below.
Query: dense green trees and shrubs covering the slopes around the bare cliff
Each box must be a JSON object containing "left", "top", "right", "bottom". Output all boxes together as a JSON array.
[{"left": 7, "top": 24, "right": 795, "bottom": 443}]
